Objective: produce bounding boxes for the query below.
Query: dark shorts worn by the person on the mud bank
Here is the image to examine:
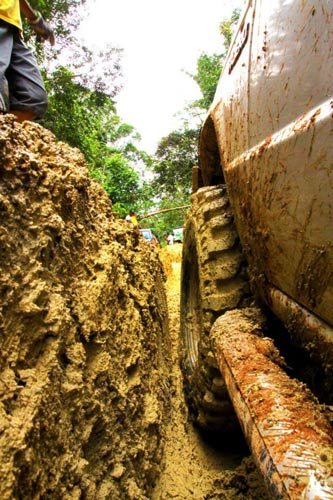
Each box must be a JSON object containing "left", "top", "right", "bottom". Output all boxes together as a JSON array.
[{"left": 0, "top": 19, "right": 47, "bottom": 118}]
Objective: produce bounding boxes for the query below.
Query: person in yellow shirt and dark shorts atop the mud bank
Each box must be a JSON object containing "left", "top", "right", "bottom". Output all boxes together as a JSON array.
[{"left": 0, "top": 0, "right": 54, "bottom": 122}]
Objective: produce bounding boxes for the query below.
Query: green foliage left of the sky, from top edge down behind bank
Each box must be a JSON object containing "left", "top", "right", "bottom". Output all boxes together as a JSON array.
[{"left": 25, "top": 0, "right": 151, "bottom": 215}]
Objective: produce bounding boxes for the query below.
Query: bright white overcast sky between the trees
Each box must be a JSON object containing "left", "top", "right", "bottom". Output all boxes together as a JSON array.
[{"left": 82, "top": 0, "right": 244, "bottom": 153}]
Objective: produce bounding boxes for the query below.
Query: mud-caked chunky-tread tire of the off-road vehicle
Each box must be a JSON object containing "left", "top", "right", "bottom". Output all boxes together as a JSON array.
[{"left": 181, "top": 186, "right": 250, "bottom": 432}]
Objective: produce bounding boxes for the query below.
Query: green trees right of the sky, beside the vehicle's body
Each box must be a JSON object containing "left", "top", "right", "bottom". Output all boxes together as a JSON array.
[{"left": 149, "top": 10, "right": 239, "bottom": 233}]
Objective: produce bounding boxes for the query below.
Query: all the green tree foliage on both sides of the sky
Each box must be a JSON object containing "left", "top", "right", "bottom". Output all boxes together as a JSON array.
[{"left": 20, "top": 0, "right": 239, "bottom": 224}]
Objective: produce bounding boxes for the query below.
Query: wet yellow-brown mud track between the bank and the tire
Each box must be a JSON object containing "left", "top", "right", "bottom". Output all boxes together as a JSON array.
[{"left": 151, "top": 245, "right": 268, "bottom": 500}]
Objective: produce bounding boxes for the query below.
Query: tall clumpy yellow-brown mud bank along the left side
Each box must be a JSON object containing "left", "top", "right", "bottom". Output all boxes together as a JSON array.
[{"left": 0, "top": 116, "right": 169, "bottom": 500}]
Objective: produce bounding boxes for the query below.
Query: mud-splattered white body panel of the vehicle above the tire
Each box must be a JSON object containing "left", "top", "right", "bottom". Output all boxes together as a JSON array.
[{"left": 200, "top": 0, "right": 333, "bottom": 325}]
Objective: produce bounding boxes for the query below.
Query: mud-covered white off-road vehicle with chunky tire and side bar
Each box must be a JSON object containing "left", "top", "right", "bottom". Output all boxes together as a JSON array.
[{"left": 181, "top": 0, "right": 333, "bottom": 499}]
